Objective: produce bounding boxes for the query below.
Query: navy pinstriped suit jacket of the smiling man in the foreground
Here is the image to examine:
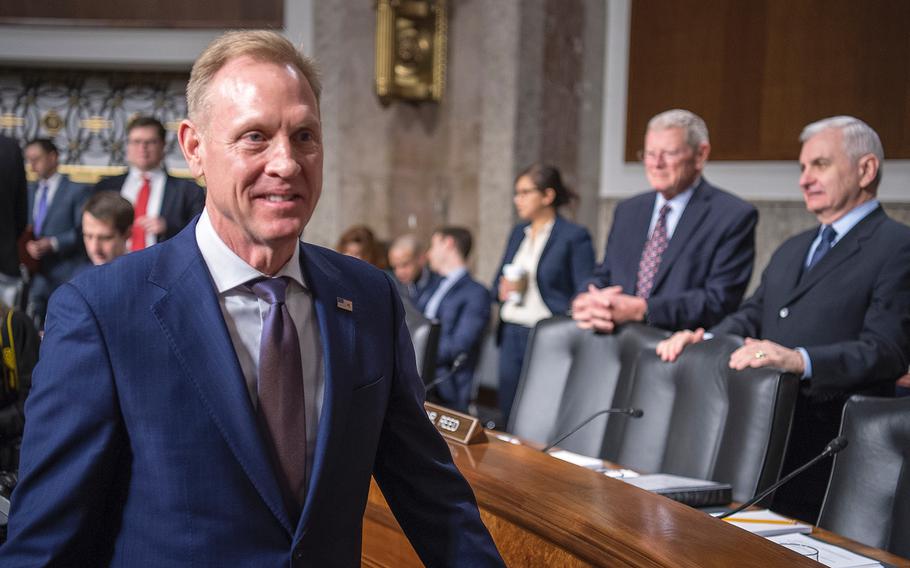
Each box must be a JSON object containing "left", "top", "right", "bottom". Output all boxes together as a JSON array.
[{"left": 0, "top": 223, "right": 501, "bottom": 567}]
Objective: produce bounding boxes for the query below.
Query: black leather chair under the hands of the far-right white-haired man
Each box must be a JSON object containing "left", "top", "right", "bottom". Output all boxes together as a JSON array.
[{"left": 611, "top": 336, "right": 799, "bottom": 501}]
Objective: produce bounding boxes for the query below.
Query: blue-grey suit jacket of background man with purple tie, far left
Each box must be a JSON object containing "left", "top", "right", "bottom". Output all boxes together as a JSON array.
[{"left": 28, "top": 175, "right": 91, "bottom": 295}]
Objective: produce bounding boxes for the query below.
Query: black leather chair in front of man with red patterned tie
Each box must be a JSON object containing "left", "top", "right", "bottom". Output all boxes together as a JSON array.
[{"left": 509, "top": 316, "right": 667, "bottom": 457}]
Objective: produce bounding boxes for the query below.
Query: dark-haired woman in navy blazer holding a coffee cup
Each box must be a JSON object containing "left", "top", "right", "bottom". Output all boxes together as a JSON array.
[{"left": 493, "top": 163, "right": 594, "bottom": 425}]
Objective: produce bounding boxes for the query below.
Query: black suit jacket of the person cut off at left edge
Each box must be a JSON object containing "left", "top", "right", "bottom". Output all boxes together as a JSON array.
[{"left": 0, "top": 135, "right": 28, "bottom": 278}]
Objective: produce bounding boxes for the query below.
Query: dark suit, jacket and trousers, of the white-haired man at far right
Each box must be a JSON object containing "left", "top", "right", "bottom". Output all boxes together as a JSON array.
[{"left": 711, "top": 208, "right": 910, "bottom": 522}]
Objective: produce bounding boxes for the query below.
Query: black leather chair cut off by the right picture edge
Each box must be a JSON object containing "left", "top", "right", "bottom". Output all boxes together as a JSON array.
[{"left": 818, "top": 395, "right": 910, "bottom": 558}]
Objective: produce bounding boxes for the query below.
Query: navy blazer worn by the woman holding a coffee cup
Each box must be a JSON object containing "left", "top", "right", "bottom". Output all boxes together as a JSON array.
[{"left": 492, "top": 215, "right": 594, "bottom": 315}]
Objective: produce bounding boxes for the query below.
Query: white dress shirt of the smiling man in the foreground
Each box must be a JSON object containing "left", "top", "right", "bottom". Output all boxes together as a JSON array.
[{"left": 196, "top": 209, "right": 325, "bottom": 472}]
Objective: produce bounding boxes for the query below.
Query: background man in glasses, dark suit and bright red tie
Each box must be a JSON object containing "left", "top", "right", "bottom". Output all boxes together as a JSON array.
[{"left": 95, "top": 116, "right": 205, "bottom": 251}]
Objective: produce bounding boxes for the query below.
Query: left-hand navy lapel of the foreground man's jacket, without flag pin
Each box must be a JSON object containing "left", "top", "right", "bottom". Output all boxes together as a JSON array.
[{"left": 149, "top": 223, "right": 293, "bottom": 534}]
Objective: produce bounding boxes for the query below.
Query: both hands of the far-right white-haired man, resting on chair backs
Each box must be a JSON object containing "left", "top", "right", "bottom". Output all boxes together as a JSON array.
[{"left": 657, "top": 328, "right": 805, "bottom": 375}]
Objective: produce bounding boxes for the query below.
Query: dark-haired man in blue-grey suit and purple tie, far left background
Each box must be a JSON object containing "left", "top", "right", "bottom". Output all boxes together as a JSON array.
[{"left": 25, "top": 138, "right": 89, "bottom": 326}]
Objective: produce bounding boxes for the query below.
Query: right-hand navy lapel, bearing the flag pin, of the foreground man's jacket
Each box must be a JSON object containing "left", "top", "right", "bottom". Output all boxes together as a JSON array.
[{"left": 296, "top": 245, "right": 359, "bottom": 535}]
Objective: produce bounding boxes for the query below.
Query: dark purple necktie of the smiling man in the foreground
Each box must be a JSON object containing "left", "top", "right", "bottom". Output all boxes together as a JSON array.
[{"left": 247, "top": 277, "right": 307, "bottom": 517}]
